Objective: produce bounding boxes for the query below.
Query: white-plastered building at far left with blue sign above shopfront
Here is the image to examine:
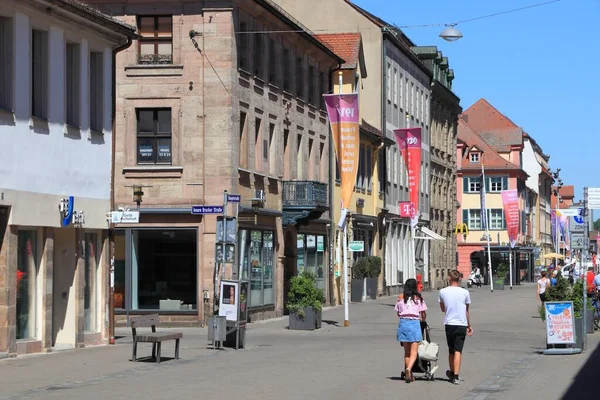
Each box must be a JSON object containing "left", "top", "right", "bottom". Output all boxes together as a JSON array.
[{"left": 0, "top": 0, "right": 135, "bottom": 358}]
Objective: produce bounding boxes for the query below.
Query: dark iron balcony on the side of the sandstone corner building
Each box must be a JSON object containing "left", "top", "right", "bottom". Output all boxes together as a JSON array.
[{"left": 283, "top": 181, "right": 329, "bottom": 226}]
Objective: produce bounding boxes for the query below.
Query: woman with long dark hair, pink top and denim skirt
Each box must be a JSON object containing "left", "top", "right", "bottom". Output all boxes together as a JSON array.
[{"left": 395, "top": 279, "right": 427, "bottom": 383}]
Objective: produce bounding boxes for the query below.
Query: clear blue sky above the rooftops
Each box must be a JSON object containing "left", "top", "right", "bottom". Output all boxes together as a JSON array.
[{"left": 354, "top": 0, "right": 600, "bottom": 199}]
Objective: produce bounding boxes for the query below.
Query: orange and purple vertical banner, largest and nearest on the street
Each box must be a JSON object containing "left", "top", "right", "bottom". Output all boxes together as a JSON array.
[{"left": 323, "top": 93, "right": 360, "bottom": 208}]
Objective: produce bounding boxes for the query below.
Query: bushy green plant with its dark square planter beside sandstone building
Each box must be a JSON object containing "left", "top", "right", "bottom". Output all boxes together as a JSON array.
[{"left": 286, "top": 271, "right": 325, "bottom": 331}]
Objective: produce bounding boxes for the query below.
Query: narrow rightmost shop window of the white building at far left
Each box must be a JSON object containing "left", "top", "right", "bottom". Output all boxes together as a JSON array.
[{"left": 83, "top": 233, "right": 100, "bottom": 332}]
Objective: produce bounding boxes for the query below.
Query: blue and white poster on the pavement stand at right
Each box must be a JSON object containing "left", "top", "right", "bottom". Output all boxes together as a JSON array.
[{"left": 544, "top": 301, "right": 575, "bottom": 344}]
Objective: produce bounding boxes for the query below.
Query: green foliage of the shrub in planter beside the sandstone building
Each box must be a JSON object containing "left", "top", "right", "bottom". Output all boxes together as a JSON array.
[{"left": 286, "top": 271, "right": 325, "bottom": 317}]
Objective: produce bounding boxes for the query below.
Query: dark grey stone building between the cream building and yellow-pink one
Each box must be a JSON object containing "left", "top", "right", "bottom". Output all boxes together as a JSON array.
[{"left": 412, "top": 46, "right": 462, "bottom": 289}]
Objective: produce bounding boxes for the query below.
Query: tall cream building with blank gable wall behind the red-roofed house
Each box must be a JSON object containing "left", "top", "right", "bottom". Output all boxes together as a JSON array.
[{"left": 277, "top": 0, "right": 432, "bottom": 294}]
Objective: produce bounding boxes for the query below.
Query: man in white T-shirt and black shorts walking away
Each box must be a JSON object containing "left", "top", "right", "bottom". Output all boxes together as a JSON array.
[{"left": 439, "top": 270, "right": 473, "bottom": 385}]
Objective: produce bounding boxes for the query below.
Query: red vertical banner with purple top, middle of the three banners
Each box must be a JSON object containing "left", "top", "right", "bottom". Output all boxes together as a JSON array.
[{"left": 394, "top": 128, "right": 421, "bottom": 228}]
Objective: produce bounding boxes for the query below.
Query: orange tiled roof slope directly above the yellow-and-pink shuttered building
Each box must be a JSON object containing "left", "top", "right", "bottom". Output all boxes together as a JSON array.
[{"left": 458, "top": 119, "right": 519, "bottom": 170}]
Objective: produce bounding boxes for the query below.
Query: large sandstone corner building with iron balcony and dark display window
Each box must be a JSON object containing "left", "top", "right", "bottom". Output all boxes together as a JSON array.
[{"left": 87, "top": 0, "right": 343, "bottom": 325}]
